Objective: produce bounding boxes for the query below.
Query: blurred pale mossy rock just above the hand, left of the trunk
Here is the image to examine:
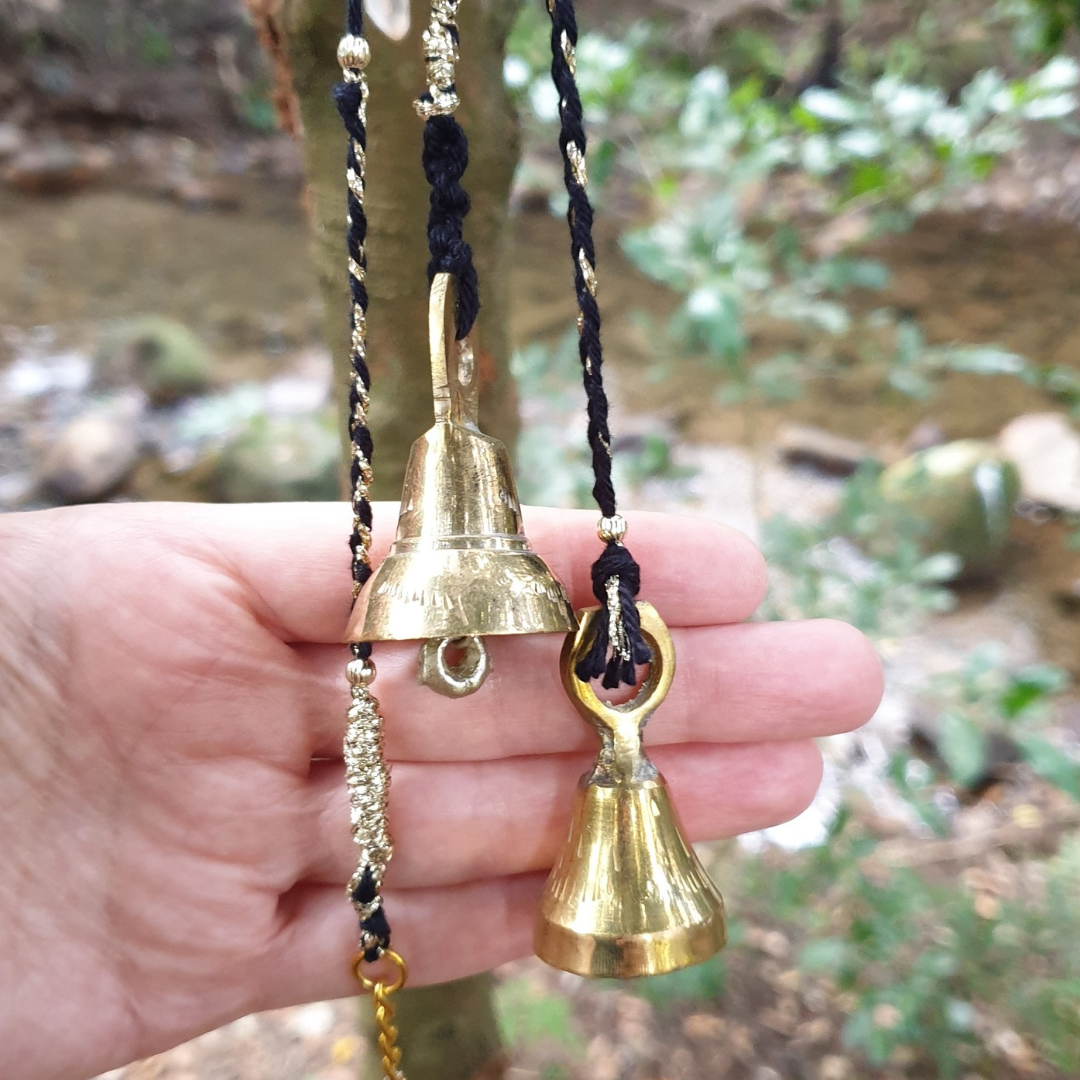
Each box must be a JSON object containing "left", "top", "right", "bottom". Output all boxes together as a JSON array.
[{"left": 211, "top": 414, "right": 341, "bottom": 502}]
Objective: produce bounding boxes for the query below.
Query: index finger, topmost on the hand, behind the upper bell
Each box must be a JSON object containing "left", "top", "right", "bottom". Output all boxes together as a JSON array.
[{"left": 168, "top": 502, "right": 766, "bottom": 644}]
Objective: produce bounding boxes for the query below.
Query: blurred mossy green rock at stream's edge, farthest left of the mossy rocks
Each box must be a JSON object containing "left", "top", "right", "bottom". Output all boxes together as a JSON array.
[{"left": 94, "top": 315, "right": 214, "bottom": 405}]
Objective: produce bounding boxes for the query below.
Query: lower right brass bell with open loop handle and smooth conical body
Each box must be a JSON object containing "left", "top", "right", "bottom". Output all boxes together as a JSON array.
[{"left": 534, "top": 603, "right": 726, "bottom": 978}]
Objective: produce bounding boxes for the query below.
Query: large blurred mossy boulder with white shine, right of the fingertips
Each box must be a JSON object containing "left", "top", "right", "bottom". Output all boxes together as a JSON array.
[{"left": 878, "top": 438, "right": 1020, "bottom": 575}]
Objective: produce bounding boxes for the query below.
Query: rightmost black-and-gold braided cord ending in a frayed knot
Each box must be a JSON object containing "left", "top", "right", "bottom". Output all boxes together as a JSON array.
[{"left": 546, "top": 0, "right": 652, "bottom": 689}]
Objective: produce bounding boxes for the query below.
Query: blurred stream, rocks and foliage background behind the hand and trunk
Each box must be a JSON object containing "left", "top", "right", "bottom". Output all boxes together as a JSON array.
[{"left": 6, "top": 0, "right": 1080, "bottom": 1080}]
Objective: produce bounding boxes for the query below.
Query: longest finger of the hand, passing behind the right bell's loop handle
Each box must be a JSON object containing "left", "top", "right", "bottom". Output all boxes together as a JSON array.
[{"left": 297, "top": 619, "right": 881, "bottom": 761}]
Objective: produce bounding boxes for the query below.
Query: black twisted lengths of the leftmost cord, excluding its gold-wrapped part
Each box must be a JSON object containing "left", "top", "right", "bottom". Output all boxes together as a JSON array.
[{"left": 334, "top": 0, "right": 390, "bottom": 963}]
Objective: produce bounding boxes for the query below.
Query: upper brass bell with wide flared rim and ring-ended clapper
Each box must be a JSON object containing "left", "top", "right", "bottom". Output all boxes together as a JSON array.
[{"left": 347, "top": 273, "right": 576, "bottom": 697}]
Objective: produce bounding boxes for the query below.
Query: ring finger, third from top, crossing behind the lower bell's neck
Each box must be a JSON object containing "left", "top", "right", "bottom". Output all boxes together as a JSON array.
[{"left": 301, "top": 740, "right": 821, "bottom": 889}]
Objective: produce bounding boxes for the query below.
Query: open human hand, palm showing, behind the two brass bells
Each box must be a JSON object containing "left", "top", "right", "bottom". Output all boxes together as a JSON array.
[{"left": 0, "top": 503, "right": 881, "bottom": 1080}]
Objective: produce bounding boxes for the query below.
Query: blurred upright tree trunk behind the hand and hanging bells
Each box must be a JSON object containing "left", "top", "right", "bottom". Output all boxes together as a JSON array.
[{"left": 282, "top": 0, "right": 518, "bottom": 1080}]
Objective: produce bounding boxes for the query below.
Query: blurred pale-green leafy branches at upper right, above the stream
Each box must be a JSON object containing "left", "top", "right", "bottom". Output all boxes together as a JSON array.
[{"left": 505, "top": 13, "right": 1080, "bottom": 406}]
